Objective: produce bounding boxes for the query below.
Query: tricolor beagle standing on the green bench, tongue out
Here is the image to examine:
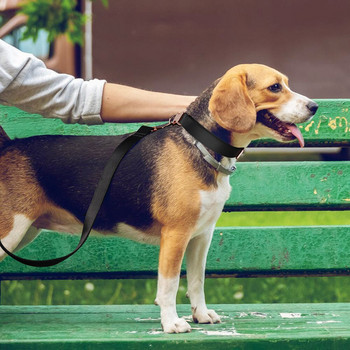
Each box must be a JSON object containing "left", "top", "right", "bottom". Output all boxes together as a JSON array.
[{"left": 0, "top": 64, "right": 318, "bottom": 333}]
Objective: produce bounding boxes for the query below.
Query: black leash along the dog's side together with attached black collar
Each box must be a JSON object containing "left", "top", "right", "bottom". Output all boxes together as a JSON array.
[{"left": 0, "top": 113, "right": 244, "bottom": 267}]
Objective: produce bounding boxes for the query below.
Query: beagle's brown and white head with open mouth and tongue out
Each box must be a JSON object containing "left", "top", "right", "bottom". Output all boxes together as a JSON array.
[{"left": 209, "top": 64, "right": 318, "bottom": 146}]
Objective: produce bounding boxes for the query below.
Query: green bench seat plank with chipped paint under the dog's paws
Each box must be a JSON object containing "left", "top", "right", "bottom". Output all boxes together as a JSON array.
[{"left": 0, "top": 303, "right": 350, "bottom": 350}]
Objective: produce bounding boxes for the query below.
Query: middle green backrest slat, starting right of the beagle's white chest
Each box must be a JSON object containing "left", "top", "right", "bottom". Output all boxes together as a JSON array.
[{"left": 225, "top": 161, "right": 350, "bottom": 211}]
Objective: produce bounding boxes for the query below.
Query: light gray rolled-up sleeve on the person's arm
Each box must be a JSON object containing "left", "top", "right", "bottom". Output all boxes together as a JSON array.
[{"left": 0, "top": 40, "right": 106, "bottom": 124}]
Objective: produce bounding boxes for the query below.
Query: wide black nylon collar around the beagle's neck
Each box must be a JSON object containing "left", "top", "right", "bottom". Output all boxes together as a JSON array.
[{"left": 174, "top": 113, "right": 244, "bottom": 158}]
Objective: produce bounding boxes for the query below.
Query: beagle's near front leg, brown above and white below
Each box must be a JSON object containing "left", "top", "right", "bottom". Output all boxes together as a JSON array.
[{"left": 155, "top": 227, "right": 191, "bottom": 333}]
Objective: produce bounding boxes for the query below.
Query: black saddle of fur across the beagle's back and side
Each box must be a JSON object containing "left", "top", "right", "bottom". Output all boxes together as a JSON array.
[{"left": 11, "top": 126, "right": 215, "bottom": 230}]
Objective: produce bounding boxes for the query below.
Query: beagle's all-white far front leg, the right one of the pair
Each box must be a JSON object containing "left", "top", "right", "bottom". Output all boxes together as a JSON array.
[{"left": 186, "top": 227, "right": 220, "bottom": 323}]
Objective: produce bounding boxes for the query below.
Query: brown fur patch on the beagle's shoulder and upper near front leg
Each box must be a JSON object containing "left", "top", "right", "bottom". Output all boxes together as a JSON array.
[{"left": 152, "top": 139, "right": 207, "bottom": 277}]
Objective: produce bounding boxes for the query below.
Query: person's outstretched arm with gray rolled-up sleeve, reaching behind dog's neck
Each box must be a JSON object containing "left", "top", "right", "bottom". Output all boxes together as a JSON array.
[{"left": 0, "top": 40, "right": 194, "bottom": 124}]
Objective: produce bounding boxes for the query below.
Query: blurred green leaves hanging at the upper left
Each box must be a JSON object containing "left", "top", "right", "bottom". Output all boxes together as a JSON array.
[{"left": 18, "top": 0, "right": 108, "bottom": 45}]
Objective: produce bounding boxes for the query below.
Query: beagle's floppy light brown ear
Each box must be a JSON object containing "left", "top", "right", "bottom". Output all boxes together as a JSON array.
[{"left": 209, "top": 67, "right": 256, "bottom": 133}]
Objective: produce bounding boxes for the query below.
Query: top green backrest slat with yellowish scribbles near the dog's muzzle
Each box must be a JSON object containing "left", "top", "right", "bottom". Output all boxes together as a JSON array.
[{"left": 0, "top": 100, "right": 350, "bottom": 147}]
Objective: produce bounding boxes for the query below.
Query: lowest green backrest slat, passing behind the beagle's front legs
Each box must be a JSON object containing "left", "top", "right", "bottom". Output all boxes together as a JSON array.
[{"left": 0, "top": 226, "right": 350, "bottom": 280}]
